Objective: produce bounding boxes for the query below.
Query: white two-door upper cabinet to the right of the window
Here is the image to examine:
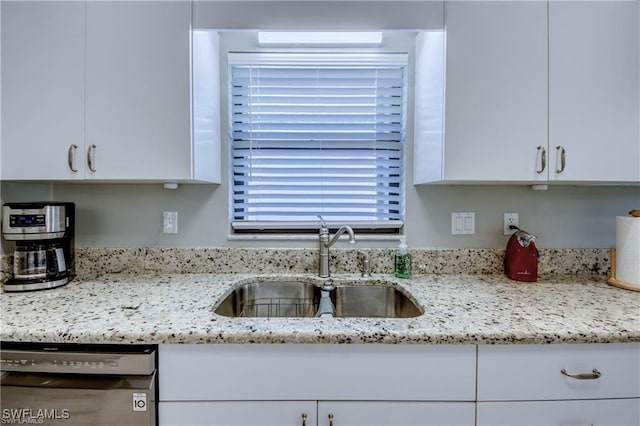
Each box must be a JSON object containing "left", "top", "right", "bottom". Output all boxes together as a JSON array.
[{"left": 414, "top": 0, "right": 640, "bottom": 184}]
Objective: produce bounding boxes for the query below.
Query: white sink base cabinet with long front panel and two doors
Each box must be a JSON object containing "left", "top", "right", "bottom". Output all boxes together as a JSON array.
[{"left": 158, "top": 344, "right": 476, "bottom": 426}]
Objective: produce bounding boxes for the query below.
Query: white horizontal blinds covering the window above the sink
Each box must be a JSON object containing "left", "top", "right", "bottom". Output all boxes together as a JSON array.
[{"left": 229, "top": 54, "right": 407, "bottom": 230}]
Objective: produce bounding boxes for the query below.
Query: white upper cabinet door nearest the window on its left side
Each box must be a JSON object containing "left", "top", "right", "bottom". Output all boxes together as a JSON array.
[{"left": 86, "top": 1, "right": 191, "bottom": 180}]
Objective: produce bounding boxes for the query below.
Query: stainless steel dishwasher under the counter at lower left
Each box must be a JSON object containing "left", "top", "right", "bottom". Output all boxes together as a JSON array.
[{"left": 0, "top": 343, "right": 158, "bottom": 426}]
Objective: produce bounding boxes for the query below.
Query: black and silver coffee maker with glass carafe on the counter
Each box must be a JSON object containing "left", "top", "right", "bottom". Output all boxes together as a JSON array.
[{"left": 2, "top": 201, "right": 75, "bottom": 291}]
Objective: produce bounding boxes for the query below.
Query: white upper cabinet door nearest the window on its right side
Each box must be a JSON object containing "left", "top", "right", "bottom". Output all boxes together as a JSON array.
[{"left": 444, "top": 1, "right": 548, "bottom": 182}]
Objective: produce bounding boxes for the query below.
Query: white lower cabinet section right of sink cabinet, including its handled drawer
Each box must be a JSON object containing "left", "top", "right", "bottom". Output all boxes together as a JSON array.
[{"left": 477, "top": 343, "right": 640, "bottom": 426}]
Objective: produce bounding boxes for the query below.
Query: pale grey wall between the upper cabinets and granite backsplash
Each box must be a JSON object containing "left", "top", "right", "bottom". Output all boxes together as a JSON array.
[{"left": 2, "top": 182, "right": 640, "bottom": 248}]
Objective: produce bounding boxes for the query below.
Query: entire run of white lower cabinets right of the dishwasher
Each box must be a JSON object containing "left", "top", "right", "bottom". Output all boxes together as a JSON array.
[{"left": 159, "top": 343, "right": 640, "bottom": 426}]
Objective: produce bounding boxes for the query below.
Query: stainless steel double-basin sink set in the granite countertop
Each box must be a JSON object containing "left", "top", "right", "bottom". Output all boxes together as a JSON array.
[{"left": 215, "top": 280, "right": 423, "bottom": 318}]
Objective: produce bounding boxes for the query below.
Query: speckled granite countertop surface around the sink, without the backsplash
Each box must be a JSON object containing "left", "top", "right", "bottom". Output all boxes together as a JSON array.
[{"left": 0, "top": 274, "right": 640, "bottom": 344}]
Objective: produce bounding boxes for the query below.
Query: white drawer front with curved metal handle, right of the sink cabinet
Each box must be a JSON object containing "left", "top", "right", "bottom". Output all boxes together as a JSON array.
[{"left": 478, "top": 343, "right": 640, "bottom": 401}]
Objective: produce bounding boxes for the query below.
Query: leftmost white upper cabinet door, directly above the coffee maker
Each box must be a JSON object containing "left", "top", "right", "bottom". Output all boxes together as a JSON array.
[{"left": 0, "top": 1, "right": 85, "bottom": 180}]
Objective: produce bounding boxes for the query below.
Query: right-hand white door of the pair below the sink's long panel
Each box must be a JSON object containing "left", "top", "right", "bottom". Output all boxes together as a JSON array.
[{"left": 318, "top": 401, "right": 475, "bottom": 426}]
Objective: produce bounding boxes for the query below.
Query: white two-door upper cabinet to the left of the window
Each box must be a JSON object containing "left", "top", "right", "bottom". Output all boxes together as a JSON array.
[{"left": 2, "top": 1, "right": 220, "bottom": 182}]
